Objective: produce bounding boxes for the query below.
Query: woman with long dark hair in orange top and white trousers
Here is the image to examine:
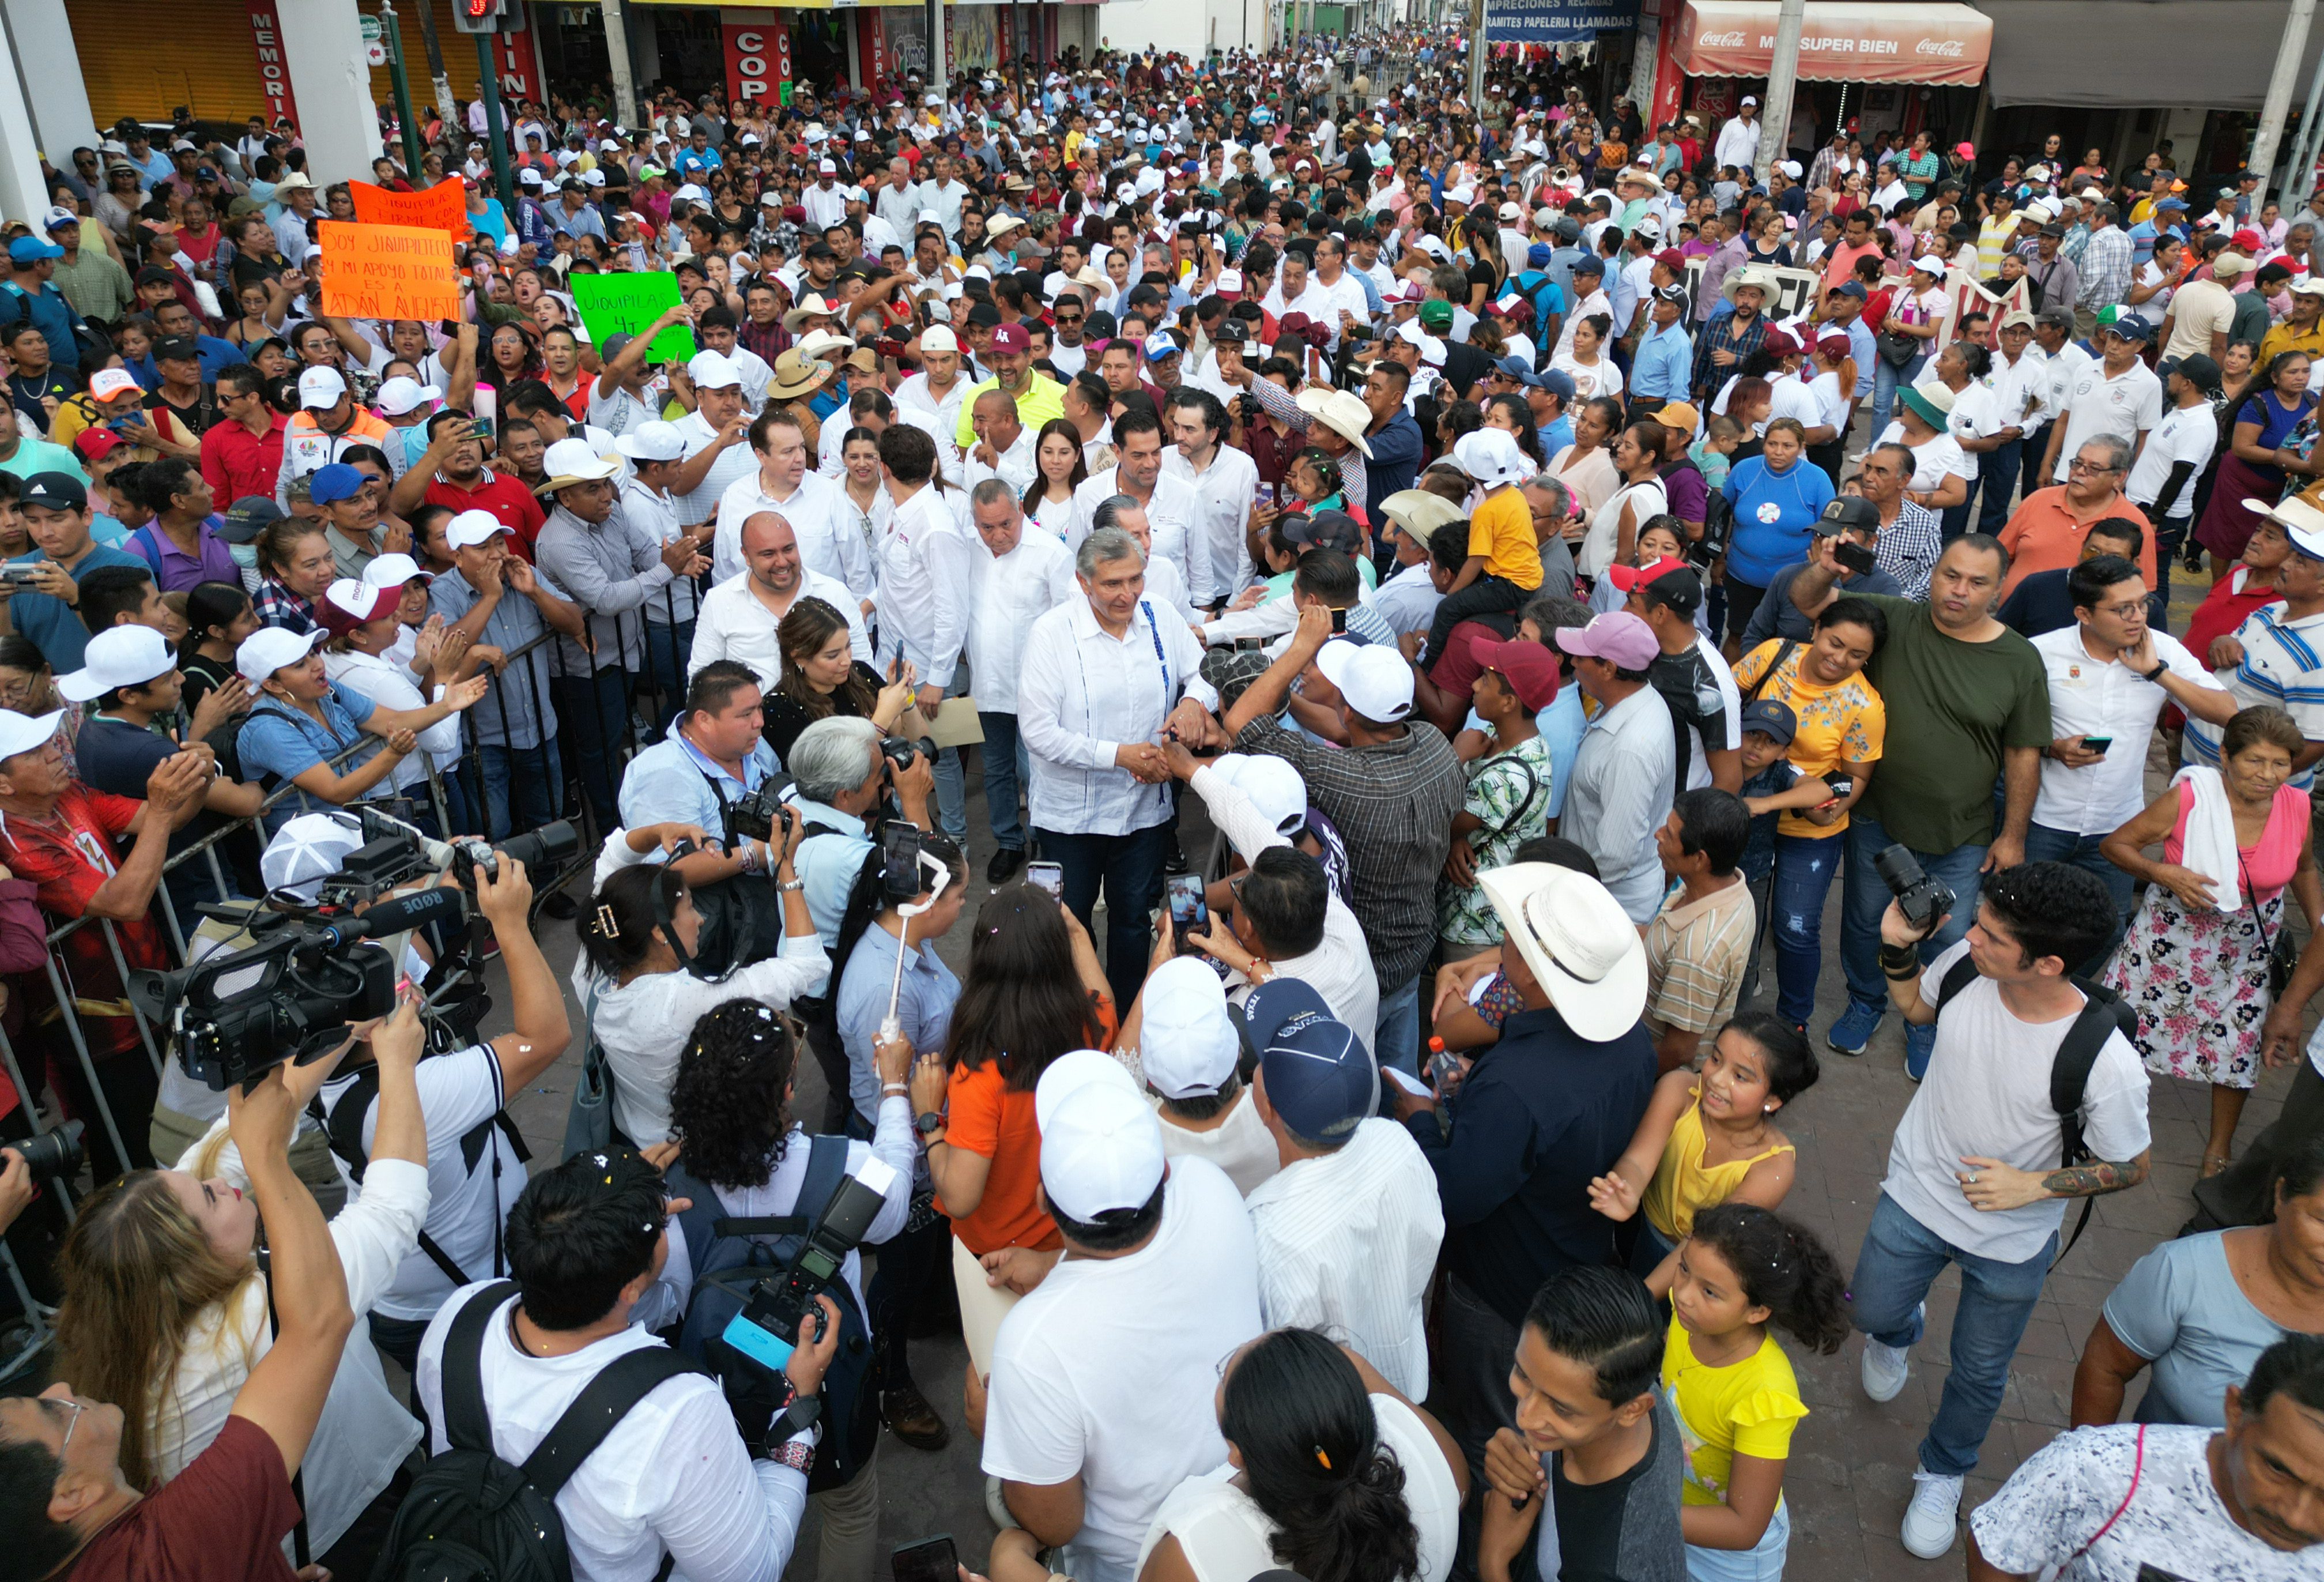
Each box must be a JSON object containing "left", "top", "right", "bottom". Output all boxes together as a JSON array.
[{"left": 911, "top": 885, "right": 1120, "bottom": 1385}]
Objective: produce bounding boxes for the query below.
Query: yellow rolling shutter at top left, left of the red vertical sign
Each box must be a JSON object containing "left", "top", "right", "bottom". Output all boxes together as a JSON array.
[{"left": 69, "top": 0, "right": 267, "bottom": 127}]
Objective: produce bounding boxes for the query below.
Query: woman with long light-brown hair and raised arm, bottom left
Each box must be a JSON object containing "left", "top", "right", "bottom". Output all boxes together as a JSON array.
[{"left": 56, "top": 997, "right": 428, "bottom": 1570}]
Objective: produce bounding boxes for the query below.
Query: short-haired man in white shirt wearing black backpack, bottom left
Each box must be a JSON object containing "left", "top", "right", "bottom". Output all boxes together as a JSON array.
[{"left": 409, "top": 1150, "right": 839, "bottom": 1582}]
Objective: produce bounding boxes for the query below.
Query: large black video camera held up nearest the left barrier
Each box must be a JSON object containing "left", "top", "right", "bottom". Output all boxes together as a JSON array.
[{"left": 130, "top": 890, "right": 467, "bottom": 1092}]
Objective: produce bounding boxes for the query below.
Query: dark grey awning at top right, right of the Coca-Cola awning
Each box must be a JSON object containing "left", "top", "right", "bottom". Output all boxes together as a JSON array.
[{"left": 1980, "top": 0, "right": 2324, "bottom": 110}]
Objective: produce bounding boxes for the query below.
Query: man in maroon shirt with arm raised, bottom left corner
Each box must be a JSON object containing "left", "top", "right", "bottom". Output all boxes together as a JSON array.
[{"left": 0, "top": 1041, "right": 356, "bottom": 1582}]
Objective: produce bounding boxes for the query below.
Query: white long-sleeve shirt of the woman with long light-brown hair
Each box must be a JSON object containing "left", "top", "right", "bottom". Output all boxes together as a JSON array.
[{"left": 146, "top": 1133, "right": 428, "bottom": 1554}]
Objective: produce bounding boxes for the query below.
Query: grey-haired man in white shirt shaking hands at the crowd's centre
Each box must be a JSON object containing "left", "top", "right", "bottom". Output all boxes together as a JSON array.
[{"left": 1018, "top": 528, "right": 1218, "bottom": 1006}]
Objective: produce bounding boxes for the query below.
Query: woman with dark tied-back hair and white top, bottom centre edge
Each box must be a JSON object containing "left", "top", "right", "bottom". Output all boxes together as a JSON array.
[{"left": 1139, "top": 1329, "right": 1469, "bottom": 1582}]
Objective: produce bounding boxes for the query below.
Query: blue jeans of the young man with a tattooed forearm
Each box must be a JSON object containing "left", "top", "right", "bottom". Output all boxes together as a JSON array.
[{"left": 1847, "top": 1182, "right": 2057, "bottom": 1478}]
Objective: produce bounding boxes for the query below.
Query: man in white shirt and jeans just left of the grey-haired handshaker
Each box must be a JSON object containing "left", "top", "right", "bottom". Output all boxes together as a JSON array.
[{"left": 967, "top": 476, "right": 1078, "bottom": 885}]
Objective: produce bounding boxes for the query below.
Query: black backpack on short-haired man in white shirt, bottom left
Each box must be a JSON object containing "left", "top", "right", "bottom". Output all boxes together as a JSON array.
[{"left": 372, "top": 1280, "right": 700, "bottom": 1582}]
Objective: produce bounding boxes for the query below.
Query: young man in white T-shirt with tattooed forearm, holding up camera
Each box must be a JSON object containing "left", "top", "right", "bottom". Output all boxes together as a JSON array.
[{"left": 1850, "top": 850, "right": 2150, "bottom": 1559}]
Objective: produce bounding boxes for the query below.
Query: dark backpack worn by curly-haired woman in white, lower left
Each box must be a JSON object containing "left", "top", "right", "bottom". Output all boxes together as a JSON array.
[{"left": 662, "top": 1136, "right": 881, "bottom": 1494}]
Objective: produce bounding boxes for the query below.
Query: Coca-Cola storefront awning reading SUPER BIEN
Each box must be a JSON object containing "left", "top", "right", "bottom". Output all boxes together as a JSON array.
[{"left": 1673, "top": 0, "right": 1994, "bottom": 86}]
